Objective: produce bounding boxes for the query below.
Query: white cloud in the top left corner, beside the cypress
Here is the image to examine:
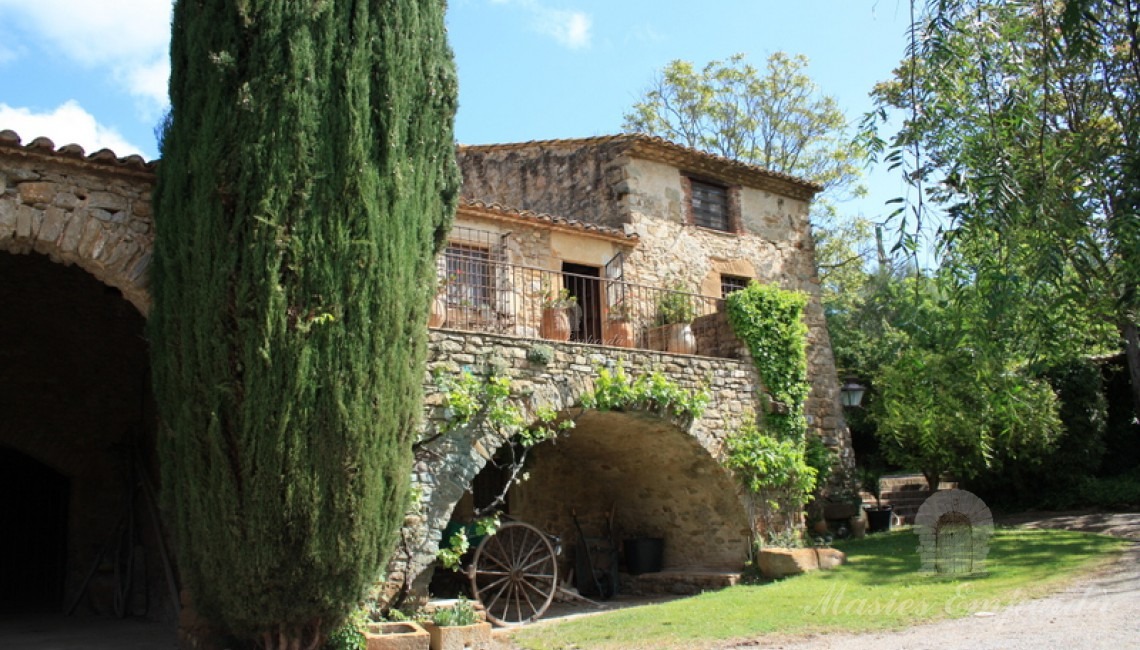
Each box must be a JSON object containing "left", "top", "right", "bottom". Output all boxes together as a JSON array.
[{"left": 0, "top": 0, "right": 171, "bottom": 112}]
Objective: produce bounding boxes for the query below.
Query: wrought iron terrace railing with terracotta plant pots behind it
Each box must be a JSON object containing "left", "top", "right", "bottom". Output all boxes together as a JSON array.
[{"left": 429, "top": 253, "right": 740, "bottom": 358}]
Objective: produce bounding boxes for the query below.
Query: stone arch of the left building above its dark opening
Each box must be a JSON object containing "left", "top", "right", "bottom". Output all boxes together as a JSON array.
[{"left": 0, "top": 131, "right": 154, "bottom": 316}]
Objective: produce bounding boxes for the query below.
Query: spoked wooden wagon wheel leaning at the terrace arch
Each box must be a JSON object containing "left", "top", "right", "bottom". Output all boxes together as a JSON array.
[{"left": 469, "top": 521, "right": 559, "bottom": 625}]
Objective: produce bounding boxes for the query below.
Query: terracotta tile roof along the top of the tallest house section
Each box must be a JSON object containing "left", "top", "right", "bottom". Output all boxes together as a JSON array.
[{"left": 459, "top": 133, "right": 823, "bottom": 200}]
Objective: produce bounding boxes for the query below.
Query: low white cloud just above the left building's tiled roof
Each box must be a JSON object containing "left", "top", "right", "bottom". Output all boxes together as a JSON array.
[{"left": 0, "top": 100, "right": 143, "bottom": 156}]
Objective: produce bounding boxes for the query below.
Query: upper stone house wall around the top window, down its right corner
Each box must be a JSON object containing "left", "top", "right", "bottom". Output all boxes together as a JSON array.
[{"left": 459, "top": 138, "right": 854, "bottom": 468}]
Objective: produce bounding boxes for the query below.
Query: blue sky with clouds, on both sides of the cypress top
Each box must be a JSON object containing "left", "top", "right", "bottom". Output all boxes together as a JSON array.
[{"left": 0, "top": 0, "right": 909, "bottom": 219}]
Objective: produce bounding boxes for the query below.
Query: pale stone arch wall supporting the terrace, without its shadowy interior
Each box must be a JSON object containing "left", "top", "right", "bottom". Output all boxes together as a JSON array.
[{"left": 389, "top": 331, "right": 759, "bottom": 591}]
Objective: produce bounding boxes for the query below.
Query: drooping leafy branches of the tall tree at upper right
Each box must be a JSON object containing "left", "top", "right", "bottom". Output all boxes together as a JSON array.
[{"left": 869, "top": 0, "right": 1140, "bottom": 414}]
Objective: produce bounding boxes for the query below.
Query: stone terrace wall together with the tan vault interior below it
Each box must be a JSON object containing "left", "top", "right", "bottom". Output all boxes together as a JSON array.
[{"left": 389, "top": 330, "right": 758, "bottom": 588}]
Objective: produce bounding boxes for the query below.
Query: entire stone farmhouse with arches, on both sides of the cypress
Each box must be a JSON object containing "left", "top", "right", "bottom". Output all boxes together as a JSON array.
[{"left": 0, "top": 131, "right": 853, "bottom": 628}]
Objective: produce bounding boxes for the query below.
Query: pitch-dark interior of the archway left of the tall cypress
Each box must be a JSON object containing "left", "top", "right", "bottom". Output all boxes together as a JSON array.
[{"left": 0, "top": 253, "right": 165, "bottom": 619}]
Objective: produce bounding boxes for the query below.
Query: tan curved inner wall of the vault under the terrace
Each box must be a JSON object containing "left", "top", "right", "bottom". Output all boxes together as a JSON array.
[{"left": 511, "top": 411, "right": 750, "bottom": 570}]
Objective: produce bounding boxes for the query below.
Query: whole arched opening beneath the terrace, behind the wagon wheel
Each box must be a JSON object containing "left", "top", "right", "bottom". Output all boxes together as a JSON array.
[{"left": 429, "top": 408, "right": 750, "bottom": 598}]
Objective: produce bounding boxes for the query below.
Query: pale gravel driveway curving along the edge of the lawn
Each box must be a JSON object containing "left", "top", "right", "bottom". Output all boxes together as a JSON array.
[{"left": 719, "top": 513, "right": 1140, "bottom": 650}]
